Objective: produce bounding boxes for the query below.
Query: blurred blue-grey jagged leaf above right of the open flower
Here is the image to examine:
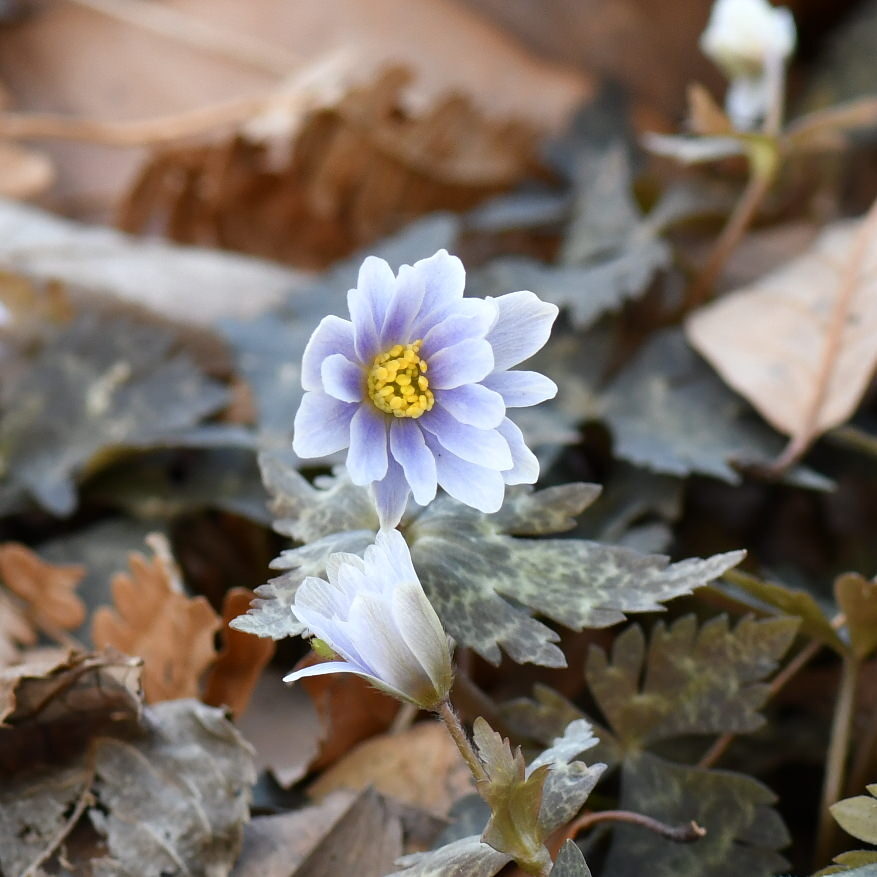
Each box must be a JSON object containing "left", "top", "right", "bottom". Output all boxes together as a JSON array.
[{"left": 474, "top": 143, "right": 670, "bottom": 328}]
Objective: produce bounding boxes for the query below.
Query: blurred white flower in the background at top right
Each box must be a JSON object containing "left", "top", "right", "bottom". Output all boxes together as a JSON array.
[{"left": 700, "top": 0, "right": 795, "bottom": 130}]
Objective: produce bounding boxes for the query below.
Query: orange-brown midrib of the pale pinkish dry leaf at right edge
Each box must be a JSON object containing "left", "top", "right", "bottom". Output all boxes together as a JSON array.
[{"left": 771, "top": 194, "right": 877, "bottom": 473}]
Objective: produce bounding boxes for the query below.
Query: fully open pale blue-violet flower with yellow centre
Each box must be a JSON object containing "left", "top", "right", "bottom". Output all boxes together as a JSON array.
[{"left": 293, "top": 250, "right": 557, "bottom": 527}]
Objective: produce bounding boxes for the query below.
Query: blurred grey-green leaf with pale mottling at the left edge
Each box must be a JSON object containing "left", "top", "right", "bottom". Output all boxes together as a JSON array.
[{"left": 0, "top": 313, "right": 227, "bottom": 515}]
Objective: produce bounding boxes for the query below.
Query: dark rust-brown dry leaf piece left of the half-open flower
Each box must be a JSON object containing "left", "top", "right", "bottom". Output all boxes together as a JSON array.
[{"left": 201, "top": 588, "right": 276, "bottom": 718}]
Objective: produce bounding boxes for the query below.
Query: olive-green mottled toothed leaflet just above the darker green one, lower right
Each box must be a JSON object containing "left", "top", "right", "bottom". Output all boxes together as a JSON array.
[{"left": 586, "top": 615, "right": 798, "bottom": 748}]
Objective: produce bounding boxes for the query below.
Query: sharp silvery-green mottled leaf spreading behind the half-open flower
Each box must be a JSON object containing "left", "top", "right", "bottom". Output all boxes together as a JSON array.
[{"left": 234, "top": 455, "right": 743, "bottom": 666}]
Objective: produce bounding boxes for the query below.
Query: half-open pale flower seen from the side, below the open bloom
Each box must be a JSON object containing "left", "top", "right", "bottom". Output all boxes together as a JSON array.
[{"left": 283, "top": 530, "right": 453, "bottom": 709}]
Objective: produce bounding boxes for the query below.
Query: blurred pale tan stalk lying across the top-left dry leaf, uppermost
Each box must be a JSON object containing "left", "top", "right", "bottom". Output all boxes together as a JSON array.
[{"left": 68, "top": 0, "right": 300, "bottom": 76}]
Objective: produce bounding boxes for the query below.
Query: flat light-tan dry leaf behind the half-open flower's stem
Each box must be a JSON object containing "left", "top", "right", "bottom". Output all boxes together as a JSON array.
[{"left": 308, "top": 722, "right": 472, "bottom": 816}]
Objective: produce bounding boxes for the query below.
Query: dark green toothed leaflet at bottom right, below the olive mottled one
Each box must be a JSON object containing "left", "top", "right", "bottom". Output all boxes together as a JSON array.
[{"left": 605, "top": 752, "right": 789, "bottom": 877}]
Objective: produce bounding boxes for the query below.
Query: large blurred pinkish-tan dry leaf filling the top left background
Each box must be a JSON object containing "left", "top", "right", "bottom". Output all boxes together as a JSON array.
[{"left": 0, "top": 0, "right": 591, "bottom": 220}]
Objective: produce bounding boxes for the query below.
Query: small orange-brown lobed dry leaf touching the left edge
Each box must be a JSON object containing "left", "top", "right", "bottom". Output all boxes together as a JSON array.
[{"left": 0, "top": 542, "right": 86, "bottom": 634}]
